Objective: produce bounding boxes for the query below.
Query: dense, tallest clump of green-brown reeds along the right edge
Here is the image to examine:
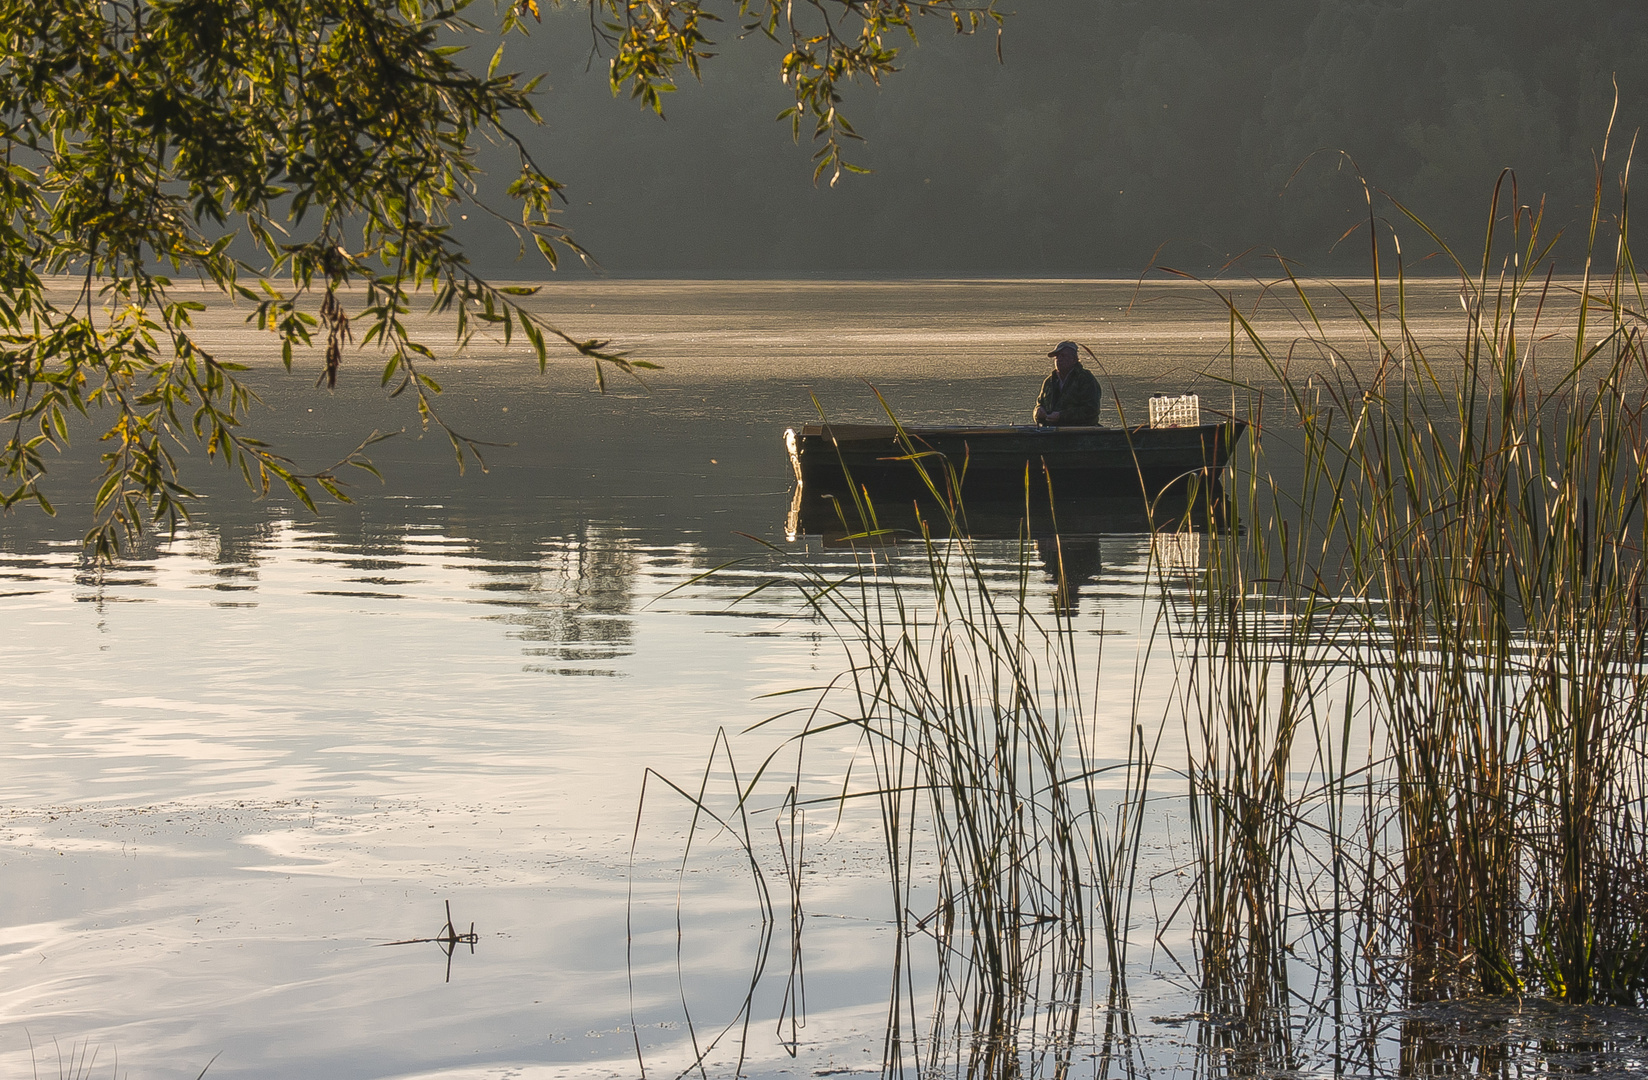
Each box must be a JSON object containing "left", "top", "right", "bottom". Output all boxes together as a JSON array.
[{"left": 1182, "top": 122, "right": 1648, "bottom": 1004}]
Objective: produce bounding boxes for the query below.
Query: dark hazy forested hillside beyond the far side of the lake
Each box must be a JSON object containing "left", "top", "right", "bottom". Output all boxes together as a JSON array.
[{"left": 471, "top": 0, "right": 1648, "bottom": 277}]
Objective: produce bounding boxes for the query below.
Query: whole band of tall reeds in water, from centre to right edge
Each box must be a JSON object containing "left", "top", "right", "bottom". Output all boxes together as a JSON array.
[{"left": 638, "top": 141, "right": 1648, "bottom": 1077}]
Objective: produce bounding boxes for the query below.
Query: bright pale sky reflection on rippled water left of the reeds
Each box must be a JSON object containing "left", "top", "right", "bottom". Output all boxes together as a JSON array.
[{"left": 0, "top": 495, "right": 1199, "bottom": 1075}]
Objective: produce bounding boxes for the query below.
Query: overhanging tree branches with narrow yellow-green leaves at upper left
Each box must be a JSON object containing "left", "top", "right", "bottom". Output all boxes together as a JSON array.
[{"left": 0, "top": 0, "right": 999, "bottom": 557}]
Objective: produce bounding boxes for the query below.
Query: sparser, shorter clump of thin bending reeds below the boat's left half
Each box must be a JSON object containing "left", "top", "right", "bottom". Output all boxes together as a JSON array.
[{"left": 801, "top": 448, "right": 1094, "bottom": 1077}]
